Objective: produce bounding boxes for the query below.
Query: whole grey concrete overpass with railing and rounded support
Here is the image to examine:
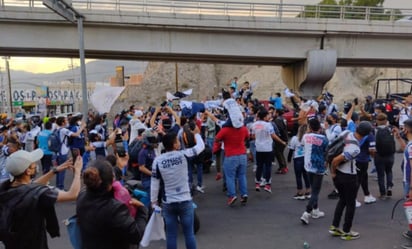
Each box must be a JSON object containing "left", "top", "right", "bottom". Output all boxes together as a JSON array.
[{"left": 0, "top": 0, "right": 412, "bottom": 95}]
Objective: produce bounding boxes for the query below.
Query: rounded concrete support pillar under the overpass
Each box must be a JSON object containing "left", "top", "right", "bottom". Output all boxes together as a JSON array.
[{"left": 282, "top": 49, "right": 338, "bottom": 98}]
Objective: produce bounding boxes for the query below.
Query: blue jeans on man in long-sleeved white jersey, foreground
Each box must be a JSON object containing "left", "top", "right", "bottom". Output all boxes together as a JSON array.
[{"left": 162, "top": 201, "right": 196, "bottom": 249}]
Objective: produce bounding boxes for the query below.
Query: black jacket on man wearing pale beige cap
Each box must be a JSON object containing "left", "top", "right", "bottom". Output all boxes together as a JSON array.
[{"left": 0, "top": 181, "right": 60, "bottom": 249}]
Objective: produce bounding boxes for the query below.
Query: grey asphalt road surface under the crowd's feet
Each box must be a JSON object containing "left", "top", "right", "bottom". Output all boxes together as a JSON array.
[{"left": 37, "top": 154, "right": 408, "bottom": 249}]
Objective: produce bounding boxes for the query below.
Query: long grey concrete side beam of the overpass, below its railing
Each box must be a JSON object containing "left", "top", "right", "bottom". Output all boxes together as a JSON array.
[{"left": 0, "top": 20, "right": 412, "bottom": 67}]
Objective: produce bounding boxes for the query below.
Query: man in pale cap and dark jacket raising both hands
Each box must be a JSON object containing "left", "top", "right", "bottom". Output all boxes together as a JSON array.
[{"left": 0, "top": 149, "right": 82, "bottom": 249}]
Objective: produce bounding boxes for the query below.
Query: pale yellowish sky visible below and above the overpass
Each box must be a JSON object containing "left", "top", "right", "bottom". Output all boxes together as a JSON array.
[{"left": 4, "top": 0, "right": 412, "bottom": 73}]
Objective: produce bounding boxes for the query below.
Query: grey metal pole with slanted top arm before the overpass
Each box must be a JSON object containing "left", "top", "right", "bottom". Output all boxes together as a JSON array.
[{"left": 43, "top": 0, "right": 89, "bottom": 118}]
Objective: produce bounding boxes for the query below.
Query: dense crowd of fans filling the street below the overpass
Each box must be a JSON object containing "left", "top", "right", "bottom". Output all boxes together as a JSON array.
[{"left": 0, "top": 78, "right": 412, "bottom": 249}]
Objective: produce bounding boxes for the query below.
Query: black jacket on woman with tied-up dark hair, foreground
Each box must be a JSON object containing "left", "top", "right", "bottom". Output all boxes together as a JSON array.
[{"left": 76, "top": 190, "right": 148, "bottom": 249}]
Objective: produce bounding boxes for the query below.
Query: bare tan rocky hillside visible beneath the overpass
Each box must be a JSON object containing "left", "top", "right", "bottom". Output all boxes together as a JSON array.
[{"left": 112, "top": 62, "right": 412, "bottom": 112}]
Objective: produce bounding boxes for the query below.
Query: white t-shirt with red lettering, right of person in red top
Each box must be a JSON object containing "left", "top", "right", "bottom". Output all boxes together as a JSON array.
[{"left": 251, "top": 120, "right": 275, "bottom": 152}]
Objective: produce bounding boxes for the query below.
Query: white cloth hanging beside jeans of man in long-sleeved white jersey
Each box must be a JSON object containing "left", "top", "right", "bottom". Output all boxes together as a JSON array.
[{"left": 140, "top": 206, "right": 166, "bottom": 247}]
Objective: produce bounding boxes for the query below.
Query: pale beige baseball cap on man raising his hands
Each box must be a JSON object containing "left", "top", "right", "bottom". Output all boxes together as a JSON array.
[{"left": 6, "top": 149, "right": 43, "bottom": 177}]
